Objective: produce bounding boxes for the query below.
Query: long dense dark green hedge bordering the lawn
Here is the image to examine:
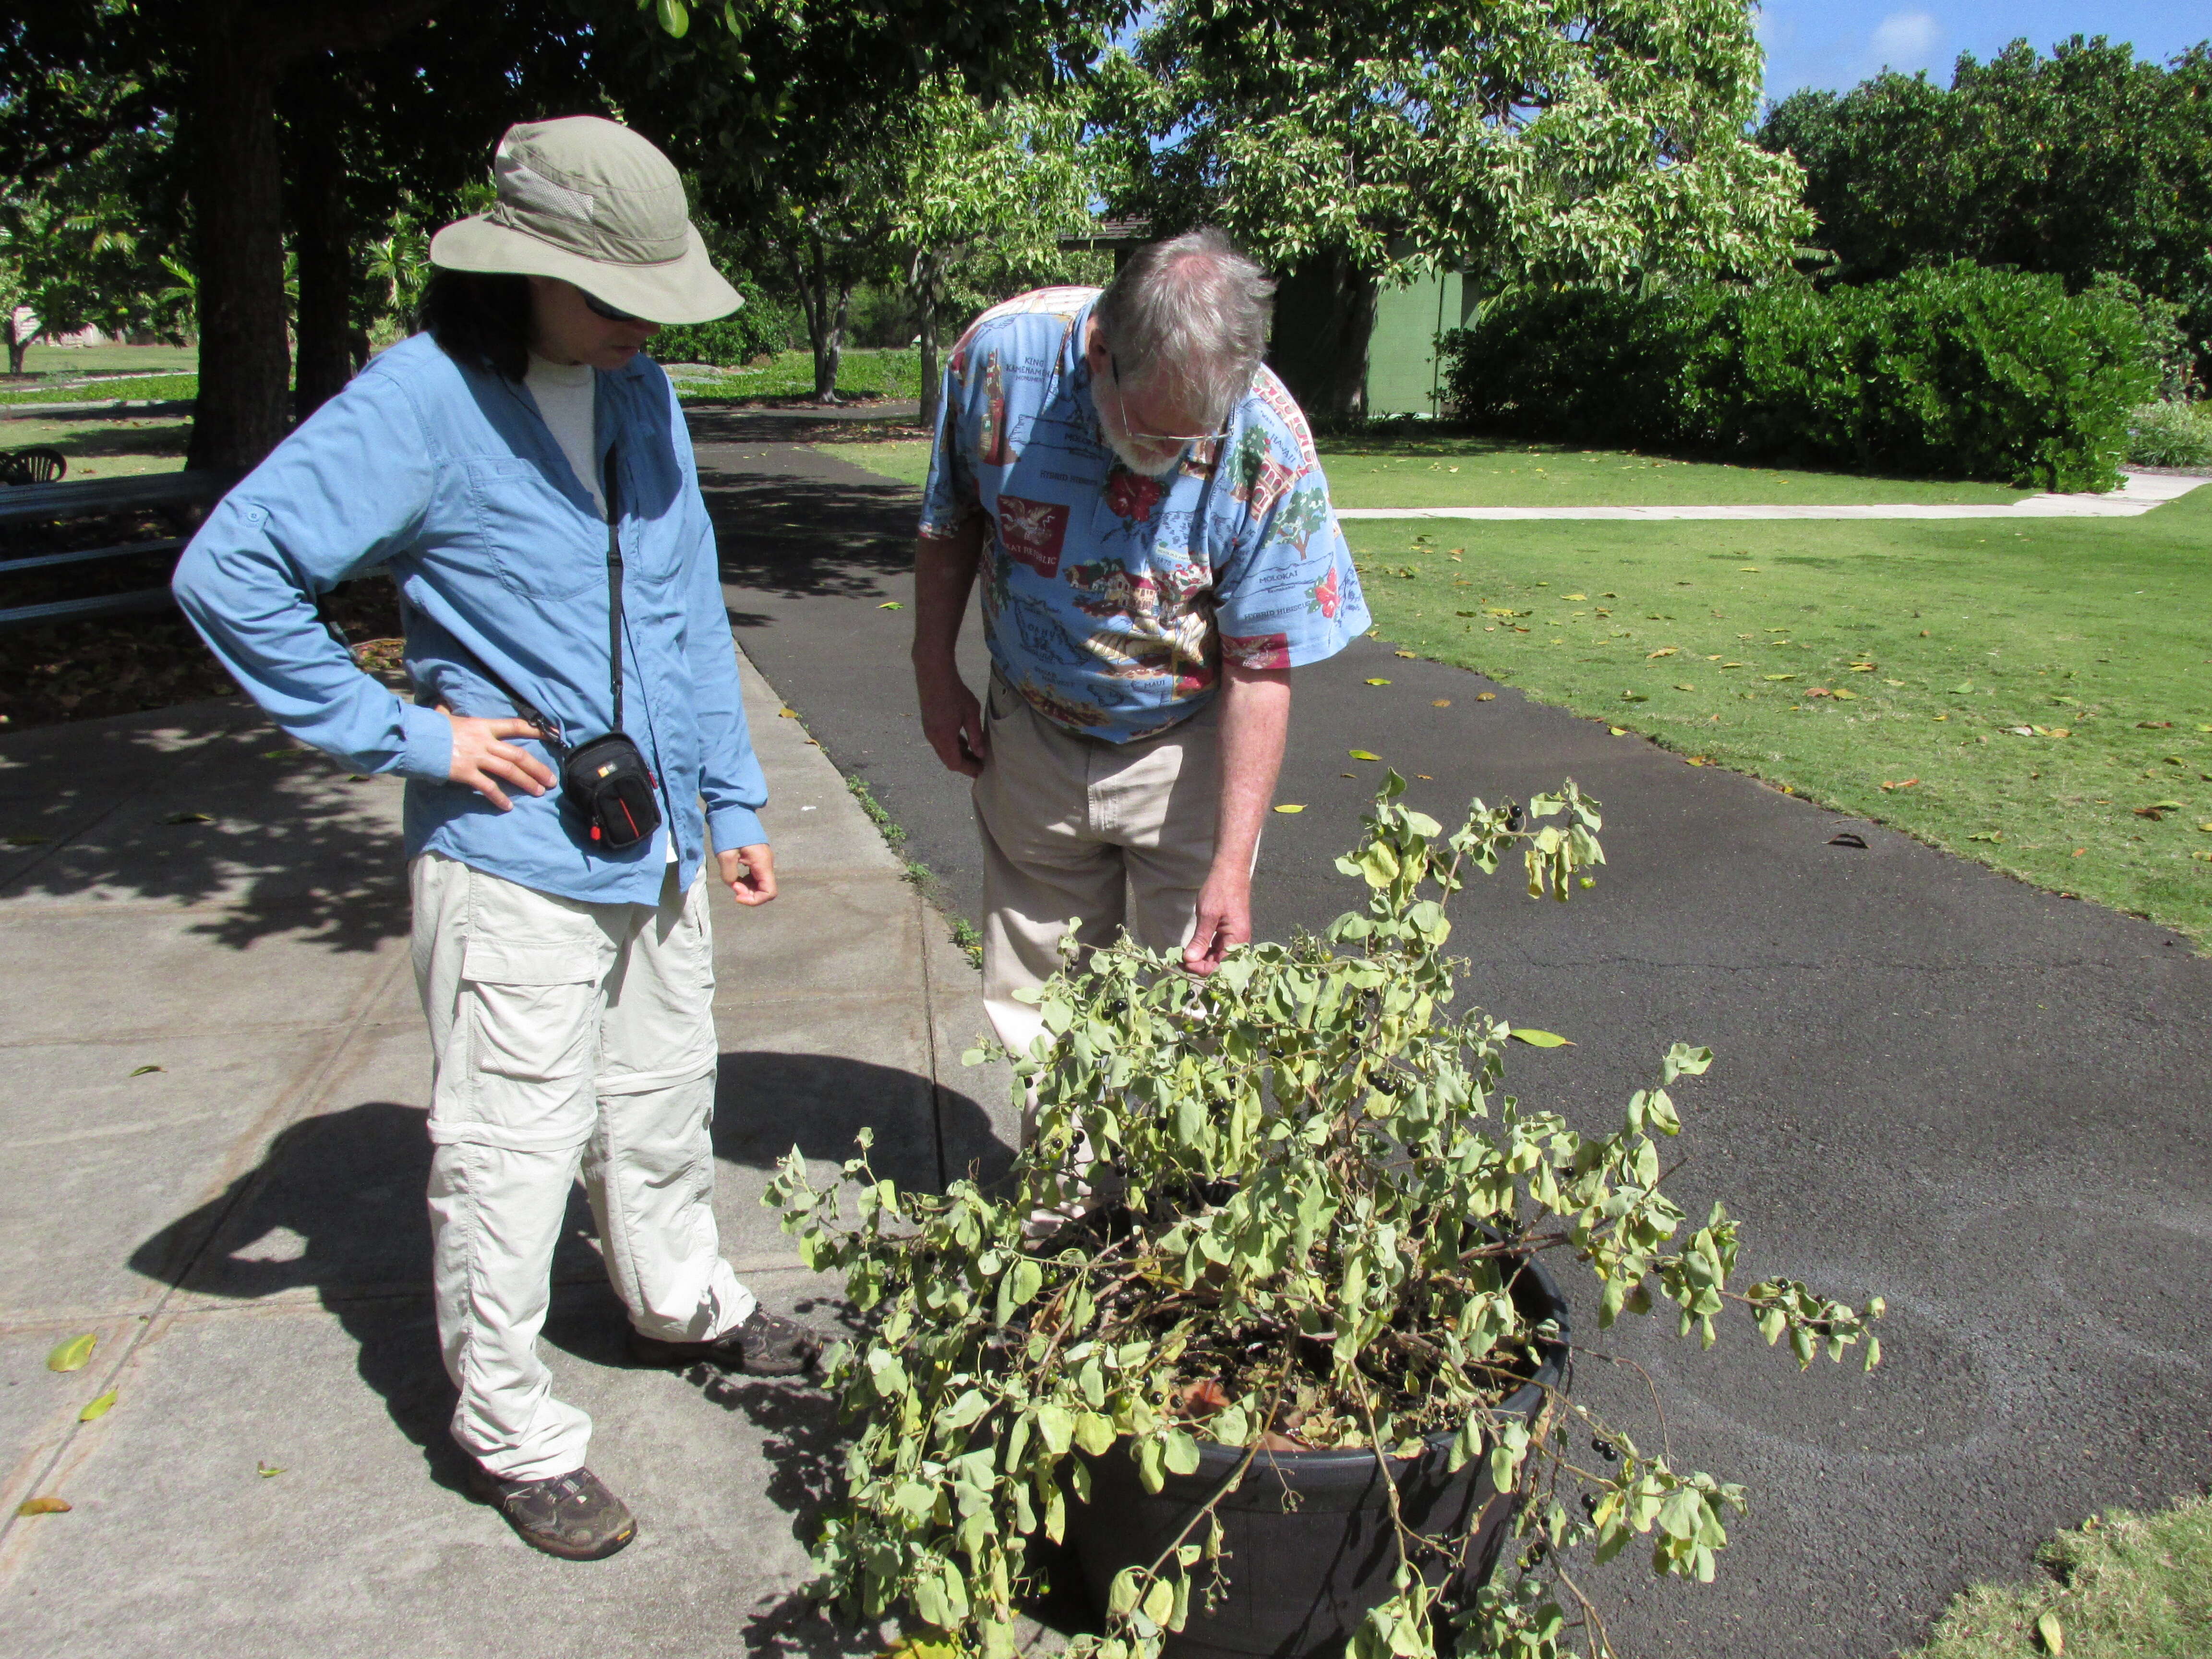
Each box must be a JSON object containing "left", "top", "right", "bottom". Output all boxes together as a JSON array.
[{"left": 1444, "top": 261, "right": 2159, "bottom": 489}]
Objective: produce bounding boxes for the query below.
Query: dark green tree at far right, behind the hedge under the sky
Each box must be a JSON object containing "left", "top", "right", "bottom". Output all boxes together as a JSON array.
[{"left": 1758, "top": 36, "right": 2212, "bottom": 374}]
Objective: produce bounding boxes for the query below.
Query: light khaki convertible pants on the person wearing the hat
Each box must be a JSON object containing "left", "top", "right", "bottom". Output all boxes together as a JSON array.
[{"left": 407, "top": 854, "right": 754, "bottom": 1480}]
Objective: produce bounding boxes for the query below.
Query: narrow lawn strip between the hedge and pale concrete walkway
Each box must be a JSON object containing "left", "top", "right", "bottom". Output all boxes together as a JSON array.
[{"left": 838, "top": 438, "right": 2029, "bottom": 506}]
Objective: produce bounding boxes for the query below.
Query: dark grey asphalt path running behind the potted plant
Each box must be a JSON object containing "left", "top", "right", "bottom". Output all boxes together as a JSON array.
[{"left": 697, "top": 431, "right": 2212, "bottom": 1659}]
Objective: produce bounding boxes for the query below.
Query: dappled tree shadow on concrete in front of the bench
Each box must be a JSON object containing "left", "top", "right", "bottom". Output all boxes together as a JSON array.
[{"left": 0, "top": 701, "right": 407, "bottom": 951}]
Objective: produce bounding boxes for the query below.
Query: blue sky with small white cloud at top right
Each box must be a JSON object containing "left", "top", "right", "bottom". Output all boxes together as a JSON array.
[{"left": 1758, "top": 0, "right": 2212, "bottom": 97}]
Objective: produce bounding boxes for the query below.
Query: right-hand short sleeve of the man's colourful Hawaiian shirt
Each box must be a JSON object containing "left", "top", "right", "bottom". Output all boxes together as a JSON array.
[{"left": 1214, "top": 422, "right": 1367, "bottom": 668}]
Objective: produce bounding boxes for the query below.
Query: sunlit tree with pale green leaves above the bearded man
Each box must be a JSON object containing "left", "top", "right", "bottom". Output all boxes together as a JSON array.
[{"left": 1102, "top": 0, "right": 1809, "bottom": 414}]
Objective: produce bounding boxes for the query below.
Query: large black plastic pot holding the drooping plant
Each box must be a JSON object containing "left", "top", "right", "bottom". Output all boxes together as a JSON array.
[{"left": 1069, "top": 1263, "right": 1568, "bottom": 1659}]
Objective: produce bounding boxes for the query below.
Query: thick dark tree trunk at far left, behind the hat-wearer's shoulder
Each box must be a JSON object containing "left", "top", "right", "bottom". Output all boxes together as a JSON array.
[{"left": 179, "top": 0, "right": 292, "bottom": 471}]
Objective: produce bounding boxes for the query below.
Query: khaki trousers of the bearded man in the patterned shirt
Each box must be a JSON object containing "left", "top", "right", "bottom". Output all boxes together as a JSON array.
[{"left": 975, "top": 674, "right": 1221, "bottom": 1053}]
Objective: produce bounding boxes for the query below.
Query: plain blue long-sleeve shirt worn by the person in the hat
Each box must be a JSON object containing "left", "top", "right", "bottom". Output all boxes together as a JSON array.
[{"left": 175, "top": 334, "right": 768, "bottom": 905}]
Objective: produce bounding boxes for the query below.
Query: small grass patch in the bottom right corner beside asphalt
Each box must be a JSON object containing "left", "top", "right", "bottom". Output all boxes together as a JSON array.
[{"left": 1902, "top": 1498, "right": 2212, "bottom": 1659}]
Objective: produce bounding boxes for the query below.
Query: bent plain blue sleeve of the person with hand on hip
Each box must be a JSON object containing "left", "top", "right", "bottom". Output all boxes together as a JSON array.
[{"left": 170, "top": 372, "right": 454, "bottom": 781}]
